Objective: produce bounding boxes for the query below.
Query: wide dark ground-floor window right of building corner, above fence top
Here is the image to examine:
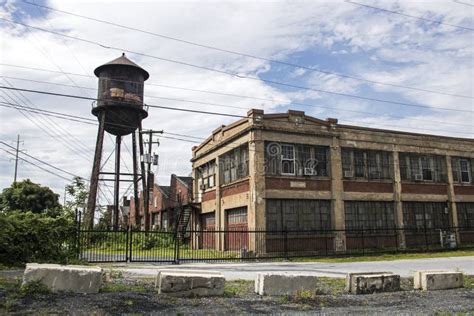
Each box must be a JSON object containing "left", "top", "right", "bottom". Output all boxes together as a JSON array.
[{"left": 266, "top": 199, "right": 331, "bottom": 231}]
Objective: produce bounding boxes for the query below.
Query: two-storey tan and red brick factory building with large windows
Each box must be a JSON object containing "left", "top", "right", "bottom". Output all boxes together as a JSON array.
[{"left": 192, "top": 109, "right": 474, "bottom": 252}]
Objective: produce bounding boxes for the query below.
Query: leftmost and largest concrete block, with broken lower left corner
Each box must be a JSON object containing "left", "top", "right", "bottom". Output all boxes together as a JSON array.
[{"left": 23, "top": 263, "right": 102, "bottom": 293}]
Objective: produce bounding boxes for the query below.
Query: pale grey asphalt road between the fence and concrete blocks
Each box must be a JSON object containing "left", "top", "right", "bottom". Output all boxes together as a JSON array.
[{"left": 102, "top": 256, "right": 474, "bottom": 280}]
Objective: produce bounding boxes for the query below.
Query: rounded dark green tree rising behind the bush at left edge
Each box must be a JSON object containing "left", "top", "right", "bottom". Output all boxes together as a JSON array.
[{"left": 0, "top": 179, "right": 62, "bottom": 216}]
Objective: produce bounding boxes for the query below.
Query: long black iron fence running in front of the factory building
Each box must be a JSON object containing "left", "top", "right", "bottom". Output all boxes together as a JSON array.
[{"left": 77, "top": 227, "right": 474, "bottom": 263}]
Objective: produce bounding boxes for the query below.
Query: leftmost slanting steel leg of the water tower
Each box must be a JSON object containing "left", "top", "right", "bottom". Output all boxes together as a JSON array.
[{"left": 84, "top": 113, "right": 105, "bottom": 229}]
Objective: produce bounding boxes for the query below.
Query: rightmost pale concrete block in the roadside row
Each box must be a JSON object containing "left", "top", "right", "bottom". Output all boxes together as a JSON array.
[{"left": 413, "top": 271, "right": 464, "bottom": 291}]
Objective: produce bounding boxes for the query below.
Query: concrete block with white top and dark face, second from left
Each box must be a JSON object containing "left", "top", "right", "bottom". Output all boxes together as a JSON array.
[{"left": 158, "top": 270, "right": 225, "bottom": 297}]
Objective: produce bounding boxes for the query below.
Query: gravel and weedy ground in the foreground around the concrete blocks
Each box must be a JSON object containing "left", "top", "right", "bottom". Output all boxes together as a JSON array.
[{"left": 0, "top": 277, "right": 474, "bottom": 315}]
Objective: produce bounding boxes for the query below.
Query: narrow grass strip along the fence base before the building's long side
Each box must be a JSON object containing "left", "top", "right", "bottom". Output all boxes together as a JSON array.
[{"left": 291, "top": 250, "right": 474, "bottom": 263}]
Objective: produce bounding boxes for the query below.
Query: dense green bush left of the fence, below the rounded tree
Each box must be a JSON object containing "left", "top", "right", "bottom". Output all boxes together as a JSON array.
[{"left": 0, "top": 211, "right": 76, "bottom": 265}]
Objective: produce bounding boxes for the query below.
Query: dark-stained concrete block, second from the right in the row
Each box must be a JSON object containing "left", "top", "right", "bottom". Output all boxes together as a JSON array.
[{"left": 351, "top": 274, "right": 400, "bottom": 294}]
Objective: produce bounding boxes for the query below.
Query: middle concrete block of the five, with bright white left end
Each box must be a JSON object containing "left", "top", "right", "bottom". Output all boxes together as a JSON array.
[{"left": 255, "top": 273, "right": 318, "bottom": 295}]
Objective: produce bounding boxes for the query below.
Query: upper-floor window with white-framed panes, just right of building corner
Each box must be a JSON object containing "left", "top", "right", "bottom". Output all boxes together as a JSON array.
[{"left": 265, "top": 142, "right": 328, "bottom": 177}]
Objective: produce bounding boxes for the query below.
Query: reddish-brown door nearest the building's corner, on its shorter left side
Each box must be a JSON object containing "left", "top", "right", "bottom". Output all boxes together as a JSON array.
[{"left": 225, "top": 206, "right": 249, "bottom": 250}]
